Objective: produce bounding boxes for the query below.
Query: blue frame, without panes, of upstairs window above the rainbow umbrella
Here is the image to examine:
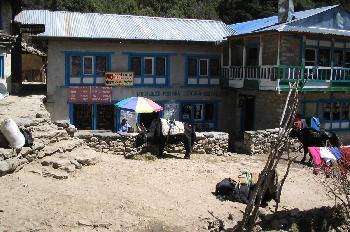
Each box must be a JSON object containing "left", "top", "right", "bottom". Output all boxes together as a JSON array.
[{"left": 127, "top": 52, "right": 174, "bottom": 87}]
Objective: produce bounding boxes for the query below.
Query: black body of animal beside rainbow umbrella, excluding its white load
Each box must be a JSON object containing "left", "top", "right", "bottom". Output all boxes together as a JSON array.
[{"left": 134, "top": 118, "right": 196, "bottom": 159}]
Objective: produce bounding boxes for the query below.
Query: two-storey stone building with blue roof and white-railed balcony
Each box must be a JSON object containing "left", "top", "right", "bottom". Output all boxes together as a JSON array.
[{"left": 222, "top": 4, "right": 350, "bottom": 141}]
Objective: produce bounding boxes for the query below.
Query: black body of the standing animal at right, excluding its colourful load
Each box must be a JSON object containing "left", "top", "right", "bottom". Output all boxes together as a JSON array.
[{"left": 289, "top": 127, "right": 340, "bottom": 163}]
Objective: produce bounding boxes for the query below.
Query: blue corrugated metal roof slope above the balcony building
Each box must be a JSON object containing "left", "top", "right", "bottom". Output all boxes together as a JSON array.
[{"left": 230, "top": 5, "right": 338, "bottom": 35}]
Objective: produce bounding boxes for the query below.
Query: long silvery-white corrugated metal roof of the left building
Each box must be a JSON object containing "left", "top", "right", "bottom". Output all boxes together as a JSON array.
[{"left": 15, "top": 10, "right": 234, "bottom": 42}]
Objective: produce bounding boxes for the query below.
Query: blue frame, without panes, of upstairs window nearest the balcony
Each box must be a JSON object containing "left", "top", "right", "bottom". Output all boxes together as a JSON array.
[{"left": 183, "top": 53, "right": 221, "bottom": 87}]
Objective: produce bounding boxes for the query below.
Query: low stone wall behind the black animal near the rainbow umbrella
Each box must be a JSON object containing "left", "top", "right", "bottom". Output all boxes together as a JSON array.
[{"left": 75, "top": 131, "right": 229, "bottom": 156}]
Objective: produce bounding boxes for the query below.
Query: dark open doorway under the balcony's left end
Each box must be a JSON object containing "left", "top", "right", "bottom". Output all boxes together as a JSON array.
[{"left": 240, "top": 95, "right": 255, "bottom": 132}]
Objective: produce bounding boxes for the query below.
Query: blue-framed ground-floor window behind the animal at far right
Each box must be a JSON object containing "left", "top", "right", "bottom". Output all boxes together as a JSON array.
[{"left": 303, "top": 98, "right": 350, "bottom": 130}]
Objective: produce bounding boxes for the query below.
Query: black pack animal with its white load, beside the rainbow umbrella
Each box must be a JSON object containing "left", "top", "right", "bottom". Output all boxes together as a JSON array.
[{"left": 134, "top": 118, "right": 196, "bottom": 159}]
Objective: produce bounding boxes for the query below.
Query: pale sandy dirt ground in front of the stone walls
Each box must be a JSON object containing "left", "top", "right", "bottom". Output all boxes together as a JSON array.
[{"left": 0, "top": 150, "right": 332, "bottom": 231}]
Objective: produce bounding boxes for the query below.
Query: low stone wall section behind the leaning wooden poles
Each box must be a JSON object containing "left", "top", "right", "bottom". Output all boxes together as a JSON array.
[{"left": 243, "top": 128, "right": 301, "bottom": 155}]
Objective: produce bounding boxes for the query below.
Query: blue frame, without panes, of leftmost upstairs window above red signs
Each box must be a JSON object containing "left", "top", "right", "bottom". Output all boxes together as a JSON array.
[{"left": 63, "top": 51, "right": 114, "bottom": 86}]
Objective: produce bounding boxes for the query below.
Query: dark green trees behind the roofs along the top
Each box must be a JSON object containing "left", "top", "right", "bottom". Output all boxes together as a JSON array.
[{"left": 24, "top": 0, "right": 350, "bottom": 24}]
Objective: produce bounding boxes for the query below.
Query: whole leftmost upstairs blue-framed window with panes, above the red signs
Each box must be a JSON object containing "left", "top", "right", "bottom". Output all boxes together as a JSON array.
[{"left": 65, "top": 52, "right": 112, "bottom": 85}]
